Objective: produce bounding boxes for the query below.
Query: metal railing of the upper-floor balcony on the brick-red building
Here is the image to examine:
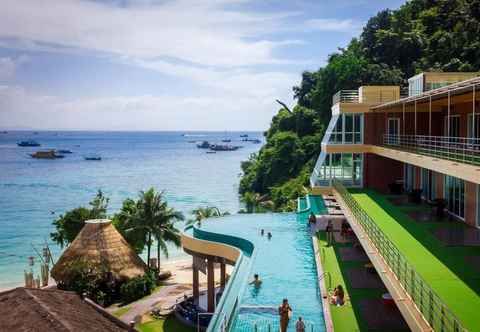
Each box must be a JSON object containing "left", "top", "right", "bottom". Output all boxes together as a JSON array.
[{"left": 383, "top": 135, "right": 480, "bottom": 165}]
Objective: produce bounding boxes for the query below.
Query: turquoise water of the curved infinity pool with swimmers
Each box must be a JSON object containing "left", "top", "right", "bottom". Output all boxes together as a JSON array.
[{"left": 201, "top": 214, "right": 325, "bottom": 332}]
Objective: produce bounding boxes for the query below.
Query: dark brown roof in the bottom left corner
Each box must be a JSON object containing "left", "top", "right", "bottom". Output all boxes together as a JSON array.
[{"left": 0, "top": 287, "right": 133, "bottom": 332}]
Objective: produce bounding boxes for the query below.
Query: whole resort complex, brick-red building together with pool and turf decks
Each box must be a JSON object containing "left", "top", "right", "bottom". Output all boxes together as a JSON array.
[{"left": 177, "top": 73, "right": 480, "bottom": 332}]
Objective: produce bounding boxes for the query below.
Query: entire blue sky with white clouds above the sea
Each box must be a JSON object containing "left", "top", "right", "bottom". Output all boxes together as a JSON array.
[{"left": 0, "top": 0, "right": 404, "bottom": 131}]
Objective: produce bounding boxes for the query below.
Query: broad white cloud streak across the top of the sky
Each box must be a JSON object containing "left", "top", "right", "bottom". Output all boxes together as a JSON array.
[{"left": 0, "top": 0, "right": 300, "bottom": 66}]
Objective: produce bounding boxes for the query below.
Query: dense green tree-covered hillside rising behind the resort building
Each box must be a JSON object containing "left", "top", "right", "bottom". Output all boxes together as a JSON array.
[{"left": 239, "top": 0, "right": 480, "bottom": 211}]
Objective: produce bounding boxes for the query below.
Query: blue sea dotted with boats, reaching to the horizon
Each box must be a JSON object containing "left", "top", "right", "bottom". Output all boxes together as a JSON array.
[{"left": 0, "top": 131, "right": 263, "bottom": 289}]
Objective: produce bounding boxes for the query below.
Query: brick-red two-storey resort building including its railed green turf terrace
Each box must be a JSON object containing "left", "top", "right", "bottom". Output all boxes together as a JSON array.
[{"left": 310, "top": 72, "right": 480, "bottom": 331}]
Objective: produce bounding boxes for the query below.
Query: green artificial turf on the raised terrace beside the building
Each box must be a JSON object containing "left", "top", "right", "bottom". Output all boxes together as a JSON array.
[{"left": 350, "top": 189, "right": 480, "bottom": 331}]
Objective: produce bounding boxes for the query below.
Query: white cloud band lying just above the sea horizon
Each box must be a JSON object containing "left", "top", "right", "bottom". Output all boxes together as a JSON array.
[{"left": 0, "top": 77, "right": 292, "bottom": 130}]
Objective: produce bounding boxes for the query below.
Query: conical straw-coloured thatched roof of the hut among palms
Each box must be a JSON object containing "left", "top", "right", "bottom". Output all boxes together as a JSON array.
[{"left": 51, "top": 219, "right": 147, "bottom": 282}]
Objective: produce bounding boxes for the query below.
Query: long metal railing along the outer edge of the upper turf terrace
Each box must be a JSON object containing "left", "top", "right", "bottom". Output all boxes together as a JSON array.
[{"left": 333, "top": 179, "right": 468, "bottom": 332}]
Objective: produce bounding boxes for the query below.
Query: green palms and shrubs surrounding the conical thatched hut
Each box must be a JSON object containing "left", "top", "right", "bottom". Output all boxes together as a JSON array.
[{"left": 51, "top": 188, "right": 184, "bottom": 305}]
